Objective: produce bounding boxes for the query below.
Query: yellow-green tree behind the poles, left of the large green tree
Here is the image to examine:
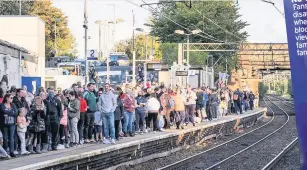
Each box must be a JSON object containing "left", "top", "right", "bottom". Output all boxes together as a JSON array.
[{"left": 113, "top": 34, "right": 162, "bottom": 60}]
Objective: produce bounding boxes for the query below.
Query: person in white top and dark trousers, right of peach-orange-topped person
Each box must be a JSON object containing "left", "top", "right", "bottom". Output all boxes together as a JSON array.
[{"left": 185, "top": 85, "right": 197, "bottom": 126}]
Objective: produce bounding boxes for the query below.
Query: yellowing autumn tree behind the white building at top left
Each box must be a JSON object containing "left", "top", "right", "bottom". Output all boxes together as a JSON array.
[{"left": 0, "top": 0, "right": 77, "bottom": 58}]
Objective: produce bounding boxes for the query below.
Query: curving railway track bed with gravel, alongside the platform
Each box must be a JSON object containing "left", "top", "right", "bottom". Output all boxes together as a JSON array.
[{"left": 158, "top": 96, "right": 297, "bottom": 170}]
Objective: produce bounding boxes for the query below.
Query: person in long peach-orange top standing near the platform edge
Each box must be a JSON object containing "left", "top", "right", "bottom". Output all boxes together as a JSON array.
[{"left": 174, "top": 88, "right": 186, "bottom": 129}]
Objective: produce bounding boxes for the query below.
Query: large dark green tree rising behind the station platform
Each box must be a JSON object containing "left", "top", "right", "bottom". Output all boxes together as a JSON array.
[{"left": 148, "top": 1, "right": 248, "bottom": 73}]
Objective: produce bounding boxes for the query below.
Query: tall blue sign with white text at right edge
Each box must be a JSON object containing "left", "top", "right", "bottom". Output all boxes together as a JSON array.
[{"left": 284, "top": 0, "right": 307, "bottom": 167}]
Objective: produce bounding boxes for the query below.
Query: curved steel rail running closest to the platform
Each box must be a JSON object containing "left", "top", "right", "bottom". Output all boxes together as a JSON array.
[{"left": 156, "top": 97, "right": 275, "bottom": 170}]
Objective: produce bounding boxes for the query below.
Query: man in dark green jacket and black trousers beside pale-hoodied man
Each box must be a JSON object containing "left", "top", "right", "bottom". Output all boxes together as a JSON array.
[{"left": 83, "top": 83, "right": 97, "bottom": 143}]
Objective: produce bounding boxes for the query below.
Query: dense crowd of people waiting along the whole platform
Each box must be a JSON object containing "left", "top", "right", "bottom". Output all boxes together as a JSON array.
[{"left": 0, "top": 82, "right": 258, "bottom": 158}]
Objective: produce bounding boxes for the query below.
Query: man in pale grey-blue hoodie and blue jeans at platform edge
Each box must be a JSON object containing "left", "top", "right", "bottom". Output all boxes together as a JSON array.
[{"left": 98, "top": 83, "right": 117, "bottom": 144}]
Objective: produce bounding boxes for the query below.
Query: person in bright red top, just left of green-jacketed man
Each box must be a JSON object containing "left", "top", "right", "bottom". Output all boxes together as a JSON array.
[{"left": 78, "top": 91, "right": 87, "bottom": 145}]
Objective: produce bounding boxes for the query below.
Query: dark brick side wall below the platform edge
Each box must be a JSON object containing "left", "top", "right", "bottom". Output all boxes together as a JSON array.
[{"left": 38, "top": 112, "right": 263, "bottom": 170}]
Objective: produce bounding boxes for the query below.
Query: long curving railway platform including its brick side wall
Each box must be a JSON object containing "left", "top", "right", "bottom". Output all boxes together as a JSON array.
[{"left": 0, "top": 108, "right": 266, "bottom": 170}]
